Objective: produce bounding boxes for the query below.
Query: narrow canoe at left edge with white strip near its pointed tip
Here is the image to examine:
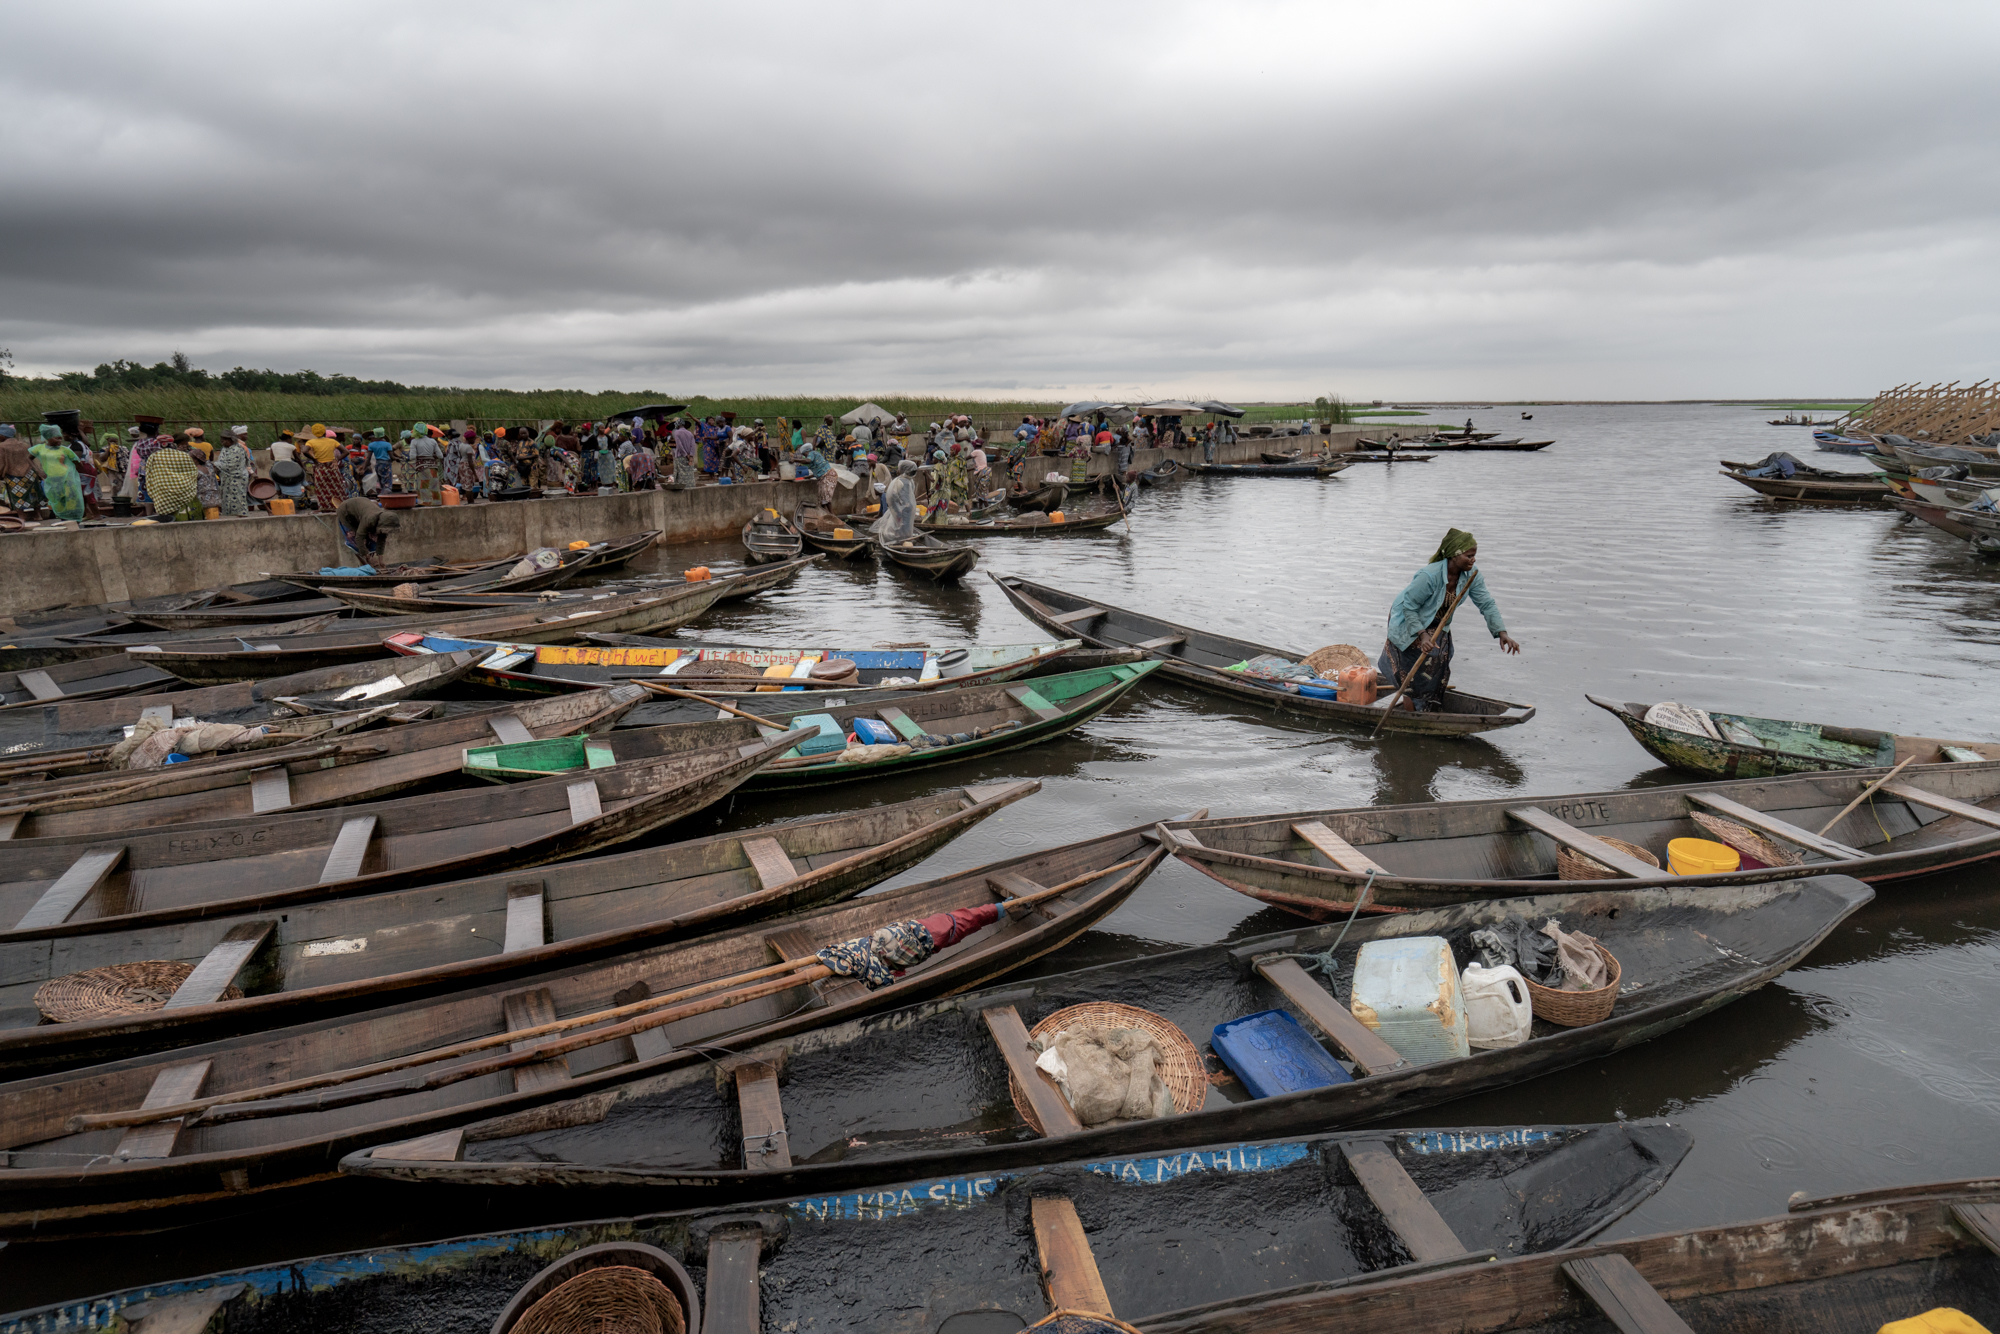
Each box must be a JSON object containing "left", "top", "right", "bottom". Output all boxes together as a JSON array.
[{"left": 0, "top": 652, "right": 480, "bottom": 754}]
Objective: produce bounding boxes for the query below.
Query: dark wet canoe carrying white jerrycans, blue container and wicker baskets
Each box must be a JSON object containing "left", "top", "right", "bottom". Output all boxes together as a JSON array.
[{"left": 344, "top": 876, "right": 1872, "bottom": 1212}]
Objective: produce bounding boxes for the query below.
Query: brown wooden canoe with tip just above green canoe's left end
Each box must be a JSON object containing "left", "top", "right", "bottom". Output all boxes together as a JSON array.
[{"left": 0, "top": 684, "right": 652, "bottom": 840}]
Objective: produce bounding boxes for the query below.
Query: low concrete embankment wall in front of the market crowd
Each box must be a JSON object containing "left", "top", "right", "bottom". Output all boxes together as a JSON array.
[{"left": 0, "top": 426, "right": 1368, "bottom": 616}]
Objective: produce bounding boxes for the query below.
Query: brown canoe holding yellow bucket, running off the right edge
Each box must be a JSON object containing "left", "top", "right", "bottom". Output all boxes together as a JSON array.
[{"left": 1176, "top": 760, "right": 2000, "bottom": 918}]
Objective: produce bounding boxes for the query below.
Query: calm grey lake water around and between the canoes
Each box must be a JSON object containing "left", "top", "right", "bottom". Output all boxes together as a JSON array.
[{"left": 0, "top": 406, "right": 2000, "bottom": 1310}]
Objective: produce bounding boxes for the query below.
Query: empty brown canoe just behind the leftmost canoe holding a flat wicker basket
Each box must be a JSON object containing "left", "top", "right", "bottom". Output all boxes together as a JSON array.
[{"left": 0, "top": 722, "right": 804, "bottom": 940}]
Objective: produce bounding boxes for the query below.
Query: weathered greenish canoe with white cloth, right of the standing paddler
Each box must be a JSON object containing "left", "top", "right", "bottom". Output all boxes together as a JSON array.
[{"left": 1584, "top": 694, "right": 2000, "bottom": 778}]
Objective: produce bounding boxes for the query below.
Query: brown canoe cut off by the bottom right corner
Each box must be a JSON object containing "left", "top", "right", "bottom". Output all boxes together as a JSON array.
[{"left": 1146, "top": 1180, "right": 2000, "bottom": 1334}]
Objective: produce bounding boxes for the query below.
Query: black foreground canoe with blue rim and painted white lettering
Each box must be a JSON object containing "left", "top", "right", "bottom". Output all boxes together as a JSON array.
[{"left": 0, "top": 1120, "right": 1692, "bottom": 1334}]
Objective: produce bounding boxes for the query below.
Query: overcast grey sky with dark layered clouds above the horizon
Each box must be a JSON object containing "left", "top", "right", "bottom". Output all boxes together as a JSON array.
[{"left": 0, "top": 0, "right": 2000, "bottom": 398}]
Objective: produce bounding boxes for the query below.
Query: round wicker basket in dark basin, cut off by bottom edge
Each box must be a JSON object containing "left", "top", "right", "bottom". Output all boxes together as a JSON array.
[{"left": 492, "top": 1242, "right": 702, "bottom": 1334}]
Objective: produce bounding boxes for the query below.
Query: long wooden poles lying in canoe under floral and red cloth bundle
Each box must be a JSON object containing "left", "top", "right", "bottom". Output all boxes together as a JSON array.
[{"left": 68, "top": 856, "right": 1146, "bottom": 1134}]
